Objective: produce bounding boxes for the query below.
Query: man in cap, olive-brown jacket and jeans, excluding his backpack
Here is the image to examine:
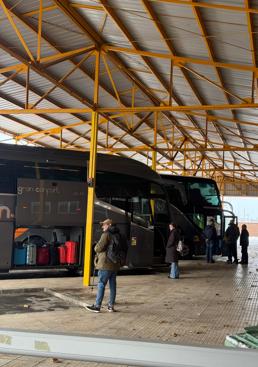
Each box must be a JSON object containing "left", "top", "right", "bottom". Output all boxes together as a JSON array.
[{"left": 86, "top": 219, "right": 120, "bottom": 312}]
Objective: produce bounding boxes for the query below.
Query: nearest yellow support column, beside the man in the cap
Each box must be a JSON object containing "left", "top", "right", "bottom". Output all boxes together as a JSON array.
[{"left": 83, "top": 52, "right": 100, "bottom": 286}]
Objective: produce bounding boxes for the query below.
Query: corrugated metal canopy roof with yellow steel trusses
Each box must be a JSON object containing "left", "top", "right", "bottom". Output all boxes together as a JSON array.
[{"left": 0, "top": 0, "right": 258, "bottom": 188}]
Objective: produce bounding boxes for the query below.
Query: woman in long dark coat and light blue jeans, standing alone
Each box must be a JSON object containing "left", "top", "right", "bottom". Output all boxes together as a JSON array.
[{"left": 165, "top": 223, "right": 180, "bottom": 279}]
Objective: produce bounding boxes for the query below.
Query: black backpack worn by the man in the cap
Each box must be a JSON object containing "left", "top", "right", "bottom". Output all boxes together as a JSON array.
[{"left": 107, "top": 232, "right": 127, "bottom": 266}]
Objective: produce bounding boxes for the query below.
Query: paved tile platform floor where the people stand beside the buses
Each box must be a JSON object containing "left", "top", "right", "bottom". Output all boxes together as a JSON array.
[{"left": 0, "top": 238, "right": 258, "bottom": 367}]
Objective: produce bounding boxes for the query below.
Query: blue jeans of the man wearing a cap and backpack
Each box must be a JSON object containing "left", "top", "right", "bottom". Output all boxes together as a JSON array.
[{"left": 95, "top": 270, "right": 116, "bottom": 307}]
